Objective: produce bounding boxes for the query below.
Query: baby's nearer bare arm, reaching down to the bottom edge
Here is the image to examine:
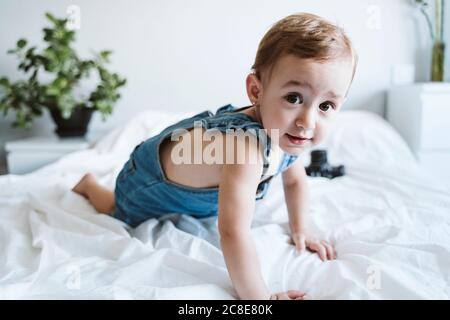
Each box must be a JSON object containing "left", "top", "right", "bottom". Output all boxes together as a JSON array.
[{"left": 218, "top": 136, "right": 304, "bottom": 300}]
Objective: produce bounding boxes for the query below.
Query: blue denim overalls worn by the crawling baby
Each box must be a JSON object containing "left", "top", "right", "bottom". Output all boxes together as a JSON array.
[{"left": 112, "top": 104, "right": 298, "bottom": 227}]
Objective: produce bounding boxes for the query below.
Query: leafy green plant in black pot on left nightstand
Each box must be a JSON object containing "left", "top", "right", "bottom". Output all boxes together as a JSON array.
[{"left": 0, "top": 13, "right": 126, "bottom": 137}]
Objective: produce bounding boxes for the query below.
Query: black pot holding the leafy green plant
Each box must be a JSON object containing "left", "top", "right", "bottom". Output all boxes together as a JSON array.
[{"left": 50, "top": 108, "right": 94, "bottom": 137}]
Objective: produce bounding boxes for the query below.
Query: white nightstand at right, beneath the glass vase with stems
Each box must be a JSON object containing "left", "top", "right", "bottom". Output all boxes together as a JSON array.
[{"left": 387, "top": 82, "right": 450, "bottom": 190}]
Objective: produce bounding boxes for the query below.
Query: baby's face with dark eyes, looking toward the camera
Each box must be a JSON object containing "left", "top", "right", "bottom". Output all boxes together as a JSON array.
[{"left": 247, "top": 55, "right": 353, "bottom": 155}]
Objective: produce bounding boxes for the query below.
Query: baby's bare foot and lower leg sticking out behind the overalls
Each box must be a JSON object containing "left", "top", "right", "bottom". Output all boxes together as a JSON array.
[{"left": 72, "top": 173, "right": 114, "bottom": 214}]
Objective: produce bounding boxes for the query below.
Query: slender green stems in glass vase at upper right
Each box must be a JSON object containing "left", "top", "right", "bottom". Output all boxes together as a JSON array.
[{"left": 415, "top": 0, "right": 445, "bottom": 81}]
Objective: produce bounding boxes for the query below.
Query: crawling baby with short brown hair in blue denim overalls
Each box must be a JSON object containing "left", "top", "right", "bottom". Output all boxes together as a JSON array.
[{"left": 73, "top": 13, "right": 357, "bottom": 300}]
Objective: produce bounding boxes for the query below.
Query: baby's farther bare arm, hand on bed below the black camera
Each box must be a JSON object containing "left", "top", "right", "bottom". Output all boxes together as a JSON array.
[{"left": 282, "top": 159, "right": 336, "bottom": 260}]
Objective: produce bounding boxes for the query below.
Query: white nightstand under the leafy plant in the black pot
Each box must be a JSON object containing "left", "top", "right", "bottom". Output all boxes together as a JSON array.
[{"left": 5, "top": 136, "right": 91, "bottom": 174}]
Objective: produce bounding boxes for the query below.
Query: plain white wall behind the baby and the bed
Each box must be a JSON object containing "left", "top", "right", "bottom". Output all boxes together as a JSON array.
[{"left": 0, "top": 0, "right": 442, "bottom": 171}]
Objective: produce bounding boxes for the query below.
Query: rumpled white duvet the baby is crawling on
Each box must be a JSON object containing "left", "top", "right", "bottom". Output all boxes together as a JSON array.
[{"left": 0, "top": 111, "right": 450, "bottom": 299}]
